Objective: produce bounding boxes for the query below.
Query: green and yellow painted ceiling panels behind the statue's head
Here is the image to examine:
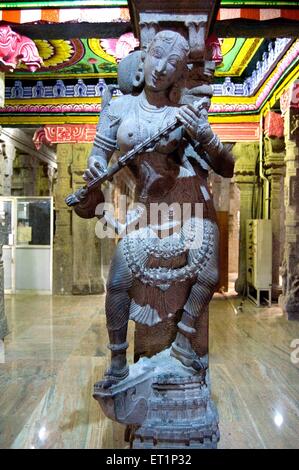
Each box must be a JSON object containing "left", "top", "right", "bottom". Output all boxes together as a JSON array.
[{"left": 7, "top": 33, "right": 291, "bottom": 83}]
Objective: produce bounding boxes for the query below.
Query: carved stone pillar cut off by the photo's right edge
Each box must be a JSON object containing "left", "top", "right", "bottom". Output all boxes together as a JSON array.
[{"left": 280, "top": 80, "right": 299, "bottom": 320}]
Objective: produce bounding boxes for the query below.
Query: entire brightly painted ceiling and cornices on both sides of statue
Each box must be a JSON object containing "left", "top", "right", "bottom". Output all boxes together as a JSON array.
[{"left": 0, "top": 0, "right": 299, "bottom": 129}]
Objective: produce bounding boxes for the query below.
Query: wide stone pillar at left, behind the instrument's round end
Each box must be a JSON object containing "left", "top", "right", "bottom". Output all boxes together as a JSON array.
[{"left": 53, "top": 143, "right": 104, "bottom": 294}]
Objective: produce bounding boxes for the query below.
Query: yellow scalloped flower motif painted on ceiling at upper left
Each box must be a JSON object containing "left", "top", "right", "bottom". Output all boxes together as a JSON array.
[{"left": 34, "top": 39, "right": 74, "bottom": 67}]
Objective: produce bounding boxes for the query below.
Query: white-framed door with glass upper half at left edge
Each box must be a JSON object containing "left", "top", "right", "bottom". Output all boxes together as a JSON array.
[{"left": 0, "top": 196, "right": 53, "bottom": 294}]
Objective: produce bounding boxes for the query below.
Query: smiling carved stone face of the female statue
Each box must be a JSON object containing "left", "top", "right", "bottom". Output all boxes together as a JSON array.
[{"left": 144, "top": 40, "right": 185, "bottom": 91}]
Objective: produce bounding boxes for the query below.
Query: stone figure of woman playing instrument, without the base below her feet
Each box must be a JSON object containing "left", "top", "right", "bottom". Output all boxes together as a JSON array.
[{"left": 84, "top": 31, "right": 233, "bottom": 388}]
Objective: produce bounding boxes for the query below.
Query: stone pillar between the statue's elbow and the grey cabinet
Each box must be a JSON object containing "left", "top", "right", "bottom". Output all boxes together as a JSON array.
[{"left": 233, "top": 142, "right": 259, "bottom": 294}]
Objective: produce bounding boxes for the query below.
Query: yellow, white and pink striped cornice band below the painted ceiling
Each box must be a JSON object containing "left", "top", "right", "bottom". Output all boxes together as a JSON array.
[{"left": 0, "top": 40, "right": 299, "bottom": 124}]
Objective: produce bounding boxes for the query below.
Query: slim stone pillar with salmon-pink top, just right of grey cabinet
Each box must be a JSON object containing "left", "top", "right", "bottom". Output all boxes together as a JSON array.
[{"left": 264, "top": 112, "right": 285, "bottom": 300}]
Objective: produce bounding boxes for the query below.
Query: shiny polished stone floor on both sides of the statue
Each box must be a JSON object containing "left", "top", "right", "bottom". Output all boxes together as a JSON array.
[{"left": 0, "top": 295, "right": 299, "bottom": 449}]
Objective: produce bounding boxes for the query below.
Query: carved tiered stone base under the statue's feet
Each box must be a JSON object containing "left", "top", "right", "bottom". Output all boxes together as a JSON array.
[{"left": 94, "top": 349, "right": 219, "bottom": 449}]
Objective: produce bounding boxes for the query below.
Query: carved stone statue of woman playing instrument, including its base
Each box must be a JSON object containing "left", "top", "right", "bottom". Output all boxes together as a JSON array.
[{"left": 68, "top": 26, "right": 234, "bottom": 447}]
